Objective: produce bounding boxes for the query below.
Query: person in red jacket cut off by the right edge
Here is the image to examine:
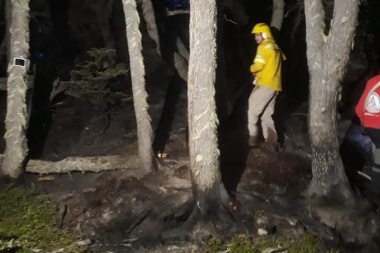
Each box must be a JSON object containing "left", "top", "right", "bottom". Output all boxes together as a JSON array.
[{"left": 355, "top": 75, "right": 380, "bottom": 193}]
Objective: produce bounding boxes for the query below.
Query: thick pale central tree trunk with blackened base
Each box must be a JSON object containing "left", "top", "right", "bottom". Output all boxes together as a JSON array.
[{"left": 188, "top": 0, "right": 230, "bottom": 217}]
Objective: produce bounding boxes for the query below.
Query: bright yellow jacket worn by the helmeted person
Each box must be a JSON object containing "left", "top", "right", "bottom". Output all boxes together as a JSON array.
[{"left": 250, "top": 34, "right": 285, "bottom": 91}]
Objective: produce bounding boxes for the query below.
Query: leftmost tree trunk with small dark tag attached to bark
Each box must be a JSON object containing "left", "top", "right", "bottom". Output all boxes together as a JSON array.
[{"left": 2, "top": 0, "right": 29, "bottom": 178}]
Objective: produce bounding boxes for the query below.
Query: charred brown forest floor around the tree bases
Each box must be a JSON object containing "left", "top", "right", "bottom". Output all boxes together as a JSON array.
[{"left": 12, "top": 60, "right": 378, "bottom": 253}]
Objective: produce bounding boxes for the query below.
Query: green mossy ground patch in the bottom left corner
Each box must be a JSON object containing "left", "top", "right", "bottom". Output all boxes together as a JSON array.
[{"left": 0, "top": 186, "right": 83, "bottom": 253}]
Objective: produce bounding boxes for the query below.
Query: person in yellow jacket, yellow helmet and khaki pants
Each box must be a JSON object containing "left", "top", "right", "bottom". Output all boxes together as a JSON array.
[{"left": 248, "top": 23, "right": 285, "bottom": 148}]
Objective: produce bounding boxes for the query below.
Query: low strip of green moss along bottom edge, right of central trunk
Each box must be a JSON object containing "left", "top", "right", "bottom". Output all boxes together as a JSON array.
[{"left": 204, "top": 235, "right": 339, "bottom": 253}]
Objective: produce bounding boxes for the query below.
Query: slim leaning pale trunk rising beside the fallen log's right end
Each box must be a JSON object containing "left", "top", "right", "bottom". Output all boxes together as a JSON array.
[{"left": 123, "top": 0, "right": 157, "bottom": 171}]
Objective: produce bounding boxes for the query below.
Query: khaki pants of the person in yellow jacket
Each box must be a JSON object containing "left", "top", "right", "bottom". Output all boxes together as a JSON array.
[{"left": 248, "top": 85, "right": 278, "bottom": 143}]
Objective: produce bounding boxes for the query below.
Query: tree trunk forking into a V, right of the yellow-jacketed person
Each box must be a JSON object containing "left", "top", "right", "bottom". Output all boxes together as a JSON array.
[{"left": 305, "top": 0, "right": 359, "bottom": 200}]
